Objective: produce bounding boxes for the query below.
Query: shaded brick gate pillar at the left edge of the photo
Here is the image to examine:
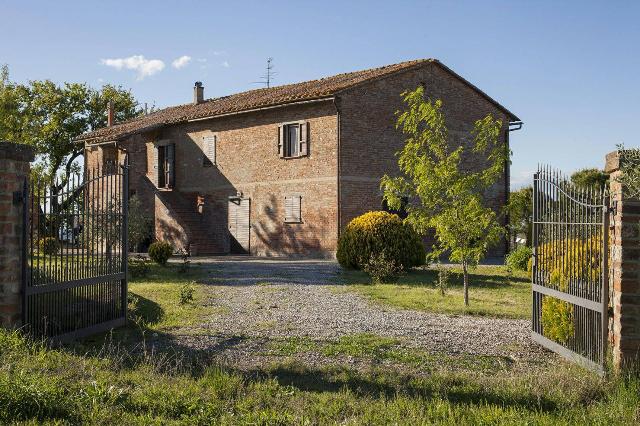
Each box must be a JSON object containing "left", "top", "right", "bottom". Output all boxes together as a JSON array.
[{"left": 0, "top": 142, "right": 33, "bottom": 327}]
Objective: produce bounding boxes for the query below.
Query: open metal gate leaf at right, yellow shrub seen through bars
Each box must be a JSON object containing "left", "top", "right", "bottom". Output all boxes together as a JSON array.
[{"left": 532, "top": 167, "right": 609, "bottom": 373}]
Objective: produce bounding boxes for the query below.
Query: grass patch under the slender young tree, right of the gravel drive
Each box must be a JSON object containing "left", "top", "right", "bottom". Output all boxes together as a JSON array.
[{"left": 338, "top": 266, "right": 531, "bottom": 318}]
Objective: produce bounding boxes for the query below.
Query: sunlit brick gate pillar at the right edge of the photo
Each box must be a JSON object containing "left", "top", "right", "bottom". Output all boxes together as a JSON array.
[{"left": 605, "top": 151, "right": 640, "bottom": 369}]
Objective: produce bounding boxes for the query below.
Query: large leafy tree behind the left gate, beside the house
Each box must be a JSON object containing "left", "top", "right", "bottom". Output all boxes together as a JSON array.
[{"left": 0, "top": 65, "right": 140, "bottom": 235}]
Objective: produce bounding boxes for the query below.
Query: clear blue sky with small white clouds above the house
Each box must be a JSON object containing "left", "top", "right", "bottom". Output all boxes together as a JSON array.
[{"left": 0, "top": 0, "right": 640, "bottom": 187}]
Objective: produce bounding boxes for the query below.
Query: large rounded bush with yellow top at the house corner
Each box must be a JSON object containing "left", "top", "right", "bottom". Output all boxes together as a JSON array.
[{"left": 336, "top": 211, "right": 426, "bottom": 269}]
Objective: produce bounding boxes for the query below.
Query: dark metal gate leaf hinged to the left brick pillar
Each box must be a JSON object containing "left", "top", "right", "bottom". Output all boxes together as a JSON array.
[{"left": 22, "top": 160, "right": 129, "bottom": 341}]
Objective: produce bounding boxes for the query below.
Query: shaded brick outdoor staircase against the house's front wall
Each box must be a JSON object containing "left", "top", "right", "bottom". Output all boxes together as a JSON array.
[{"left": 157, "top": 191, "right": 223, "bottom": 256}]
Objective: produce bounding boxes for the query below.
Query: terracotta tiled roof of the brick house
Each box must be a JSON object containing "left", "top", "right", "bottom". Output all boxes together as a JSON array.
[{"left": 77, "top": 59, "right": 517, "bottom": 143}]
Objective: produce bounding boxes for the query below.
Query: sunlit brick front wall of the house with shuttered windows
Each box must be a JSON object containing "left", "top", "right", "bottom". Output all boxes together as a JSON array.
[{"left": 87, "top": 102, "right": 337, "bottom": 256}]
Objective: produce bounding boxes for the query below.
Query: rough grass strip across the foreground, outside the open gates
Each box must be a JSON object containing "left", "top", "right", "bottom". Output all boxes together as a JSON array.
[{"left": 0, "top": 331, "right": 640, "bottom": 425}]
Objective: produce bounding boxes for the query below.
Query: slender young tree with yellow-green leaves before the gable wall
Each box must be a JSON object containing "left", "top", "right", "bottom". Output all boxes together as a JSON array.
[{"left": 380, "top": 87, "right": 510, "bottom": 306}]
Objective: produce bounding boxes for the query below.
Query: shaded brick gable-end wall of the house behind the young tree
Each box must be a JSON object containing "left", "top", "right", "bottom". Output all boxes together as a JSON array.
[{"left": 339, "top": 64, "right": 508, "bottom": 256}]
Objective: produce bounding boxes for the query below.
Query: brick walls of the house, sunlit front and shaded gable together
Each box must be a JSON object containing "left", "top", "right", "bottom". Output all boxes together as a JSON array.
[{"left": 87, "top": 64, "right": 507, "bottom": 256}]
